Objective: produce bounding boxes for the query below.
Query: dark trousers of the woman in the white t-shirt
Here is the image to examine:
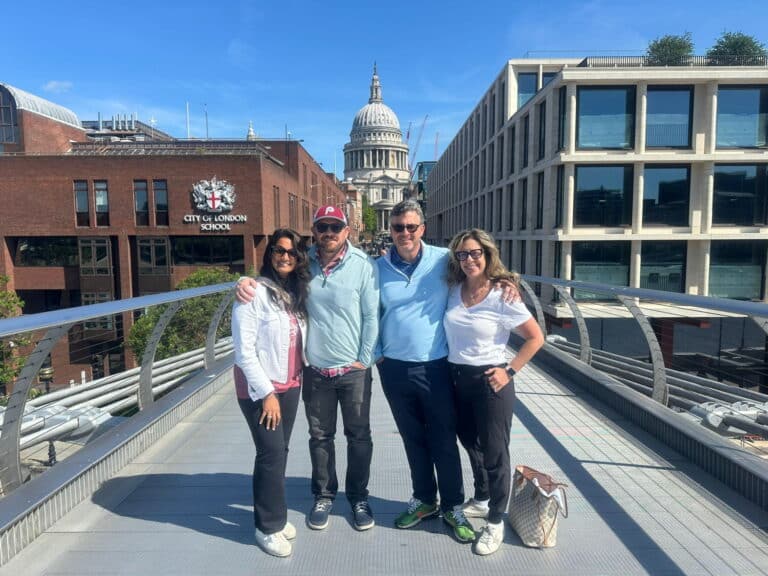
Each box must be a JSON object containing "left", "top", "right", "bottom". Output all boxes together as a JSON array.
[{"left": 451, "top": 364, "right": 515, "bottom": 523}]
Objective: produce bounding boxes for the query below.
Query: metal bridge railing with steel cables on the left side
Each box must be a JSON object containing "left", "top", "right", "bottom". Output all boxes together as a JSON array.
[{"left": 0, "top": 283, "right": 232, "bottom": 495}]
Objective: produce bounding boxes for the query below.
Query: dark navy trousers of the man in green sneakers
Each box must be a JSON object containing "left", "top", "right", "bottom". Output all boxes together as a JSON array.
[{"left": 379, "top": 358, "right": 464, "bottom": 510}]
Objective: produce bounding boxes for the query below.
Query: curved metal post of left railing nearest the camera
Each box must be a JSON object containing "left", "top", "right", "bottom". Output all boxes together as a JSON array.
[{"left": 0, "top": 323, "right": 73, "bottom": 494}]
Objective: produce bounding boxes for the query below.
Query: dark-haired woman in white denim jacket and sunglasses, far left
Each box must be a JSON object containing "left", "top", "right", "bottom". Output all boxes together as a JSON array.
[{"left": 232, "top": 228, "right": 309, "bottom": 556}]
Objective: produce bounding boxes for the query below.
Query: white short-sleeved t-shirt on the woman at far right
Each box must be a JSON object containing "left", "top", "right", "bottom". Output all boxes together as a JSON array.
[{"left": 443, "top": 285, "right": 531, "bottom": 366}]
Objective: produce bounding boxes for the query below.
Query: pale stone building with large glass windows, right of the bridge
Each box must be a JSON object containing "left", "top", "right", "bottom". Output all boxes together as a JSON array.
[{"left": 427, "top": 57, "right": 768, "bottom": 301}]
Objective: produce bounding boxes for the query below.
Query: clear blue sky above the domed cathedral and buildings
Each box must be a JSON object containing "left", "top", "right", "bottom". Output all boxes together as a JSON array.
[{"left": 0, "top": 0, "right": 768, "bottom": 177}]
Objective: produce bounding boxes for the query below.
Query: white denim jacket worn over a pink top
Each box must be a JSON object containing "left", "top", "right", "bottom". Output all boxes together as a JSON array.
[{"left": 232, "top": 278, "right": 307, "bottom": 402}]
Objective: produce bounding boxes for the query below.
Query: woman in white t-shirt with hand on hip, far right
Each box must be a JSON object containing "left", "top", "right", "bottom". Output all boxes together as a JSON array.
[{"left": 444, "top": 228, "right": 544, "bottom": 555}]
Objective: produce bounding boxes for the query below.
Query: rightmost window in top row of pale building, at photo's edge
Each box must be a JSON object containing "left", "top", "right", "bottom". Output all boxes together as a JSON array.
[{"left": 717, "top": 86, "right": 768, "bottom": 148}]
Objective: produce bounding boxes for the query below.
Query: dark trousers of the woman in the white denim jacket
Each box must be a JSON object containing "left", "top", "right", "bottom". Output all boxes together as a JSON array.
[{"left": 237, "top": 387, "right": 300, "bottom": 534}]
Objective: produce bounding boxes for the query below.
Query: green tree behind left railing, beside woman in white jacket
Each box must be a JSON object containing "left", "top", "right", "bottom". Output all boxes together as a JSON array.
[{"left": 127, "top": 268, "right": 239, "bottom": 360}]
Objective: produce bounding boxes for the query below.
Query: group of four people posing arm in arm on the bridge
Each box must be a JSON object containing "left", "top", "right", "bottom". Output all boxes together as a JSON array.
[{"left": 232, "top": 200, "right": 543, "bottom": 556}]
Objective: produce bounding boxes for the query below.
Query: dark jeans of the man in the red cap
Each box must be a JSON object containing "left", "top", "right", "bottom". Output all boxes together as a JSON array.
[{"left": 303, "top": 368, "right": 373, "bottom": 504}]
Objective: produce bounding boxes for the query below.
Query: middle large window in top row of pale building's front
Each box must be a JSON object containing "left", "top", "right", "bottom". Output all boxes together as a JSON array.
[{"left": 645, "top": 86, "right": 693, "bottom": 148}]
